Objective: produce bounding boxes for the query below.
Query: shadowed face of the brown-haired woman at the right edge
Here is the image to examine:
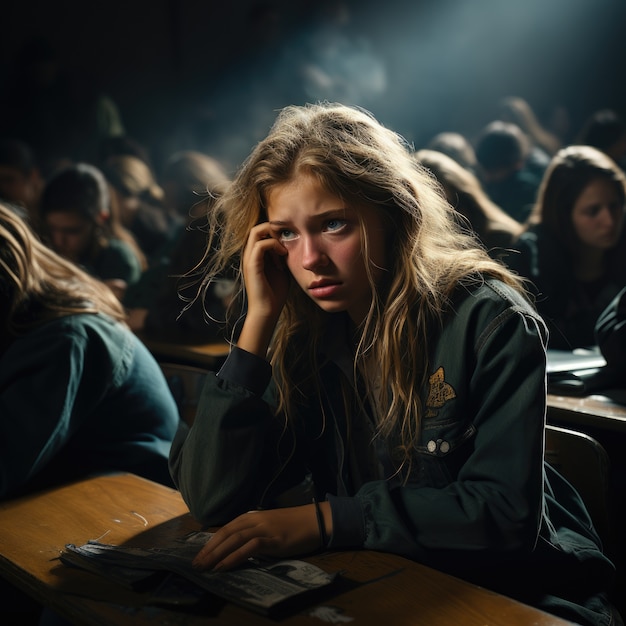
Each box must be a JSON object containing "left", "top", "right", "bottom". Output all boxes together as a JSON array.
[{"left": 572, "top": 178, "right": 624, "bottom": 250}]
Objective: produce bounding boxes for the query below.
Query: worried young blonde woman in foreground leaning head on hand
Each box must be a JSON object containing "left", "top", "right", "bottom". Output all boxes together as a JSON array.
[{"left": 170, "top": 104, "right": 614, "bottom": 624}]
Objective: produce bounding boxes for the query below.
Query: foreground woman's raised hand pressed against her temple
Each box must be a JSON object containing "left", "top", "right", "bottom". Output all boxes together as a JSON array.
[{"left": 243, "top": 223, "right": 290, "bottom": 321}]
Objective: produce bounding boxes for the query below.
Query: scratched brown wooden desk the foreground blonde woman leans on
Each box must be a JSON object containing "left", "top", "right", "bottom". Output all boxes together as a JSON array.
[{"left": 0, "top": 474, "right": 569, "bottom": 626}]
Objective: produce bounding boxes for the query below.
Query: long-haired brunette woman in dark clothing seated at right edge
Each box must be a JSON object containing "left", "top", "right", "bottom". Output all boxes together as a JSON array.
[{"left": 507, "top": 146, "right": 626, "bottom": 350}]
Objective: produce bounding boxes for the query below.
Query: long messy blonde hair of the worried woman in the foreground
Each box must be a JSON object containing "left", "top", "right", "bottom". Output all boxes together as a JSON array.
[{"left": 197, "top": 103, "right": 523, "bottom": 463}]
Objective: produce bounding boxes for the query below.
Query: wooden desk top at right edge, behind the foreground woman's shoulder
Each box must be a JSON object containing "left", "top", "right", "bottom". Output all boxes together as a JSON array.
[{"left": 547, "top": 390, "right": 626, "bottom": 433}]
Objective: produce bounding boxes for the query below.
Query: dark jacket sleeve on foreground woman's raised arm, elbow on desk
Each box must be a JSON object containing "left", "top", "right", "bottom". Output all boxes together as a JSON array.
[{"left": 170, "top": 348, "right": 304, "bottom": 525}]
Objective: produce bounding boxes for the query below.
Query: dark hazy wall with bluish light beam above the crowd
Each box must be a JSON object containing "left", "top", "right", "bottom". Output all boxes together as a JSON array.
[{"left": 0, "top": 0, "right": 626, "bottom": 171}]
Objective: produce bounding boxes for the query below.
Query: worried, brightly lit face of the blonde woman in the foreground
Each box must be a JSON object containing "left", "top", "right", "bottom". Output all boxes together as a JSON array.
[{"left": 267, "top": 174, "right": 387, "bottom": 324}]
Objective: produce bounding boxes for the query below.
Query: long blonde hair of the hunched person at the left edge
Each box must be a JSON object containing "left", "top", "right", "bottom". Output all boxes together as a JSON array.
[{"left": 0, "top": 203, "right": 125, "bottom": 340}]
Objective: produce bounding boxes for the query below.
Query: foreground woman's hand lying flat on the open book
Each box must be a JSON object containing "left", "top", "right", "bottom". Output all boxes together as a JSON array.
[{"left": 193, "top": 504, "right": 320, "bottom": 571}]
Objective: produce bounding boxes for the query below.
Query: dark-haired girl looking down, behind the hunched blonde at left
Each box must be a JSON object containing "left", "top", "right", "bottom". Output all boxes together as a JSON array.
[{"left": 40, "top": 163, "right": 146, "bottom": 298}]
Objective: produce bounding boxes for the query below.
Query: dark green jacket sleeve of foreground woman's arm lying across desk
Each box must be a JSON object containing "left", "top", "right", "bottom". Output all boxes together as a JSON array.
[{"left": 329, "top": 300, "right": 546, "bottom": 562}]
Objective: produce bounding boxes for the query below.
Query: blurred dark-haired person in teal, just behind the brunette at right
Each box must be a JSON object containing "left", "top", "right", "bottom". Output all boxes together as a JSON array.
[{"left": 476, "top": 121, "right": 543, "bottom": 223}]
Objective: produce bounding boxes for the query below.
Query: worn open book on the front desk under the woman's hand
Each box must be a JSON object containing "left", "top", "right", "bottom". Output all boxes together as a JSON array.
[{"left": 61, "top": 532, "right": 337, "bottom": 616}]
